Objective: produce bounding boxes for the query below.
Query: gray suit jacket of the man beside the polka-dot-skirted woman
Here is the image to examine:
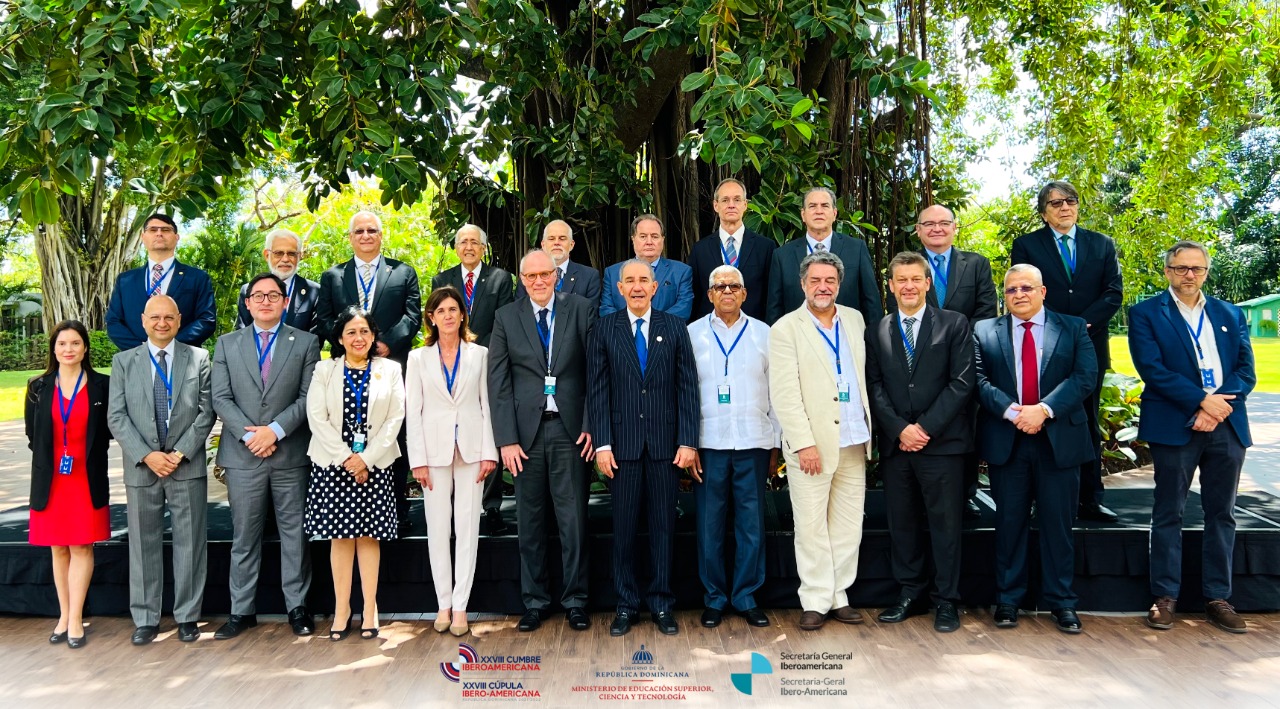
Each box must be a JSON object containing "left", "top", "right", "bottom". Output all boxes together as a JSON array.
[{"left": 212, "top": 325, "right": 320, "bottom": 470}]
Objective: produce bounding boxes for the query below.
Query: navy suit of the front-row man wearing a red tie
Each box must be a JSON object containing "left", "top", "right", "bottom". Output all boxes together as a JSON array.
[{"left": 973, "top": 310, "right": 1098, "bottom": 609}]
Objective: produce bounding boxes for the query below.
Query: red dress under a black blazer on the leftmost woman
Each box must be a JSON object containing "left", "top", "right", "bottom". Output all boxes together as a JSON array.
[{"left": 29, "top": 389, "right": 111, "bottom": 546}]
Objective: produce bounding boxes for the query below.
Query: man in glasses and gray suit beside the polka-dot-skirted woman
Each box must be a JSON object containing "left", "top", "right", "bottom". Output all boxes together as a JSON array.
[{"left": 212, "top": 272, "right": 320, "bottom": 640}]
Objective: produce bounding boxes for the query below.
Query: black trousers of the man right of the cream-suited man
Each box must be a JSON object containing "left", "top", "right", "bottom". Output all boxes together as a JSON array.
[{"left": 881, "top": 450, "right": 965, "bottom": 603}]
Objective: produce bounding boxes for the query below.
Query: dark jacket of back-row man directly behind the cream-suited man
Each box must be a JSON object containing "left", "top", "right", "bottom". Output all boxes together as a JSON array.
[{"left": 765, "top": 233, "right": 884, "bottom": 325}]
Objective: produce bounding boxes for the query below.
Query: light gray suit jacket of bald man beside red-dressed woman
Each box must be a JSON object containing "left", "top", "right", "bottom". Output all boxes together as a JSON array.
[{"left": 106, "top": 342, "right": 214, "bottom": 488}]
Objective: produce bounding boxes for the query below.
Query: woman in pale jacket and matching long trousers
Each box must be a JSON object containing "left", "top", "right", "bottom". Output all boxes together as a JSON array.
[{"left": 404, "top": 285, "right": 498, "bottom": 636}]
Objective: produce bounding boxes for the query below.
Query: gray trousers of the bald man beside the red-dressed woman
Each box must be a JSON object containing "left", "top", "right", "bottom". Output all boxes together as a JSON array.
[{"left": 124, "top": 477, "right": 209, "bottom": 626}]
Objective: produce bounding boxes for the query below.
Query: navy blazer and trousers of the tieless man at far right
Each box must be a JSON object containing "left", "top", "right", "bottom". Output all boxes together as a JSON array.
[{"left": 1129, "top": 291, "right": 1257, "bottom": 600}]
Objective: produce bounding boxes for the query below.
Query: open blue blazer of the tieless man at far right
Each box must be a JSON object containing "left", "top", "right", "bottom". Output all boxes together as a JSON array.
[{"left": 1129, "top": 291, "right": 1258, "bottom": 447}]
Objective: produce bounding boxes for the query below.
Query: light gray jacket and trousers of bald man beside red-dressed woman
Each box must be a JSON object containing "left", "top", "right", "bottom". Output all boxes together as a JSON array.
[{"left": 108, "top": 342, "right": 214, "bottom": 626}]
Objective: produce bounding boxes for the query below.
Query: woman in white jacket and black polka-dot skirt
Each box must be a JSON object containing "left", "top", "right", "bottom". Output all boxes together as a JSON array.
[{"left": 303, "top": 306, "right": 404, "bottom": 641}]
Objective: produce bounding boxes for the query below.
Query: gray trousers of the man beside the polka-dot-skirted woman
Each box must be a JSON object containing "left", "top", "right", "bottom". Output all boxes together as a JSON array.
[{"left": 227, "top": 466, "right": 311, "bottom": 616}]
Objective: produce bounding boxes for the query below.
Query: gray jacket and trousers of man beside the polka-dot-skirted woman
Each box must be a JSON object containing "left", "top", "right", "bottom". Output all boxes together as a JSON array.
[{"left": 212, "top": 324, "right": 320, "bottom": 616}]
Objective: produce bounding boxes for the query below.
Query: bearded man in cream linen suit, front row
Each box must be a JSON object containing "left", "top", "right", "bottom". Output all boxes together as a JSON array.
[{"left": 769, "top": 252, "right": 872, "bottom": 630}]
